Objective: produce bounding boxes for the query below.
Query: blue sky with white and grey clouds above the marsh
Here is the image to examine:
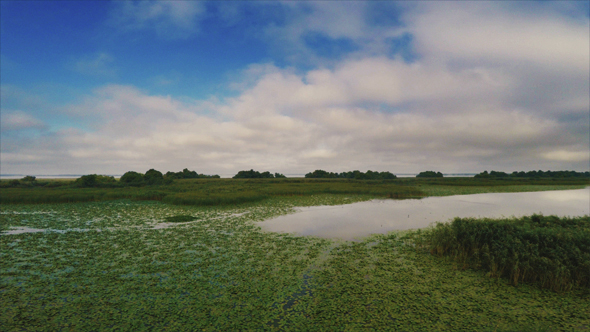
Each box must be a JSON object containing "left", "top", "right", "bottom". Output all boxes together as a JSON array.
[{"left": 0, "top": 0, "right": 590, "bottom": 175}]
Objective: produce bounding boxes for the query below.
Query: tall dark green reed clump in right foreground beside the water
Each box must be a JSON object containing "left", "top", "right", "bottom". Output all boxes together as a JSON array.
[{"left": 425, "top": 214, "right": 590, "bottom": 292}]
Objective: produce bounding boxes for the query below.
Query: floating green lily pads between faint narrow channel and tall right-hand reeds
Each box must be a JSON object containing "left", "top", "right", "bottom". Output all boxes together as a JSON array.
[{"left": 283, "top": 232, "right": 590, "bottom": 331}]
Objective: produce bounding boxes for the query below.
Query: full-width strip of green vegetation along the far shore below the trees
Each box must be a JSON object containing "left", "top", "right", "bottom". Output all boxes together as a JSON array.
[{"left": 0, "top": 175, "right": 590, "bottom": 206}]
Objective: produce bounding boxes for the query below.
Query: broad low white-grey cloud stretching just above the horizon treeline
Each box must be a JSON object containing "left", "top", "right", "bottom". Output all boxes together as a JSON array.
[{"left": 2, "top": 73, "right": 584, "bottom": 174}]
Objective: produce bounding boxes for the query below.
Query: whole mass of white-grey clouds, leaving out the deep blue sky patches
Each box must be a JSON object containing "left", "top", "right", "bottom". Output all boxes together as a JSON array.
[{"left": 2, "top": 2, "right": 590, "bottom": 174}]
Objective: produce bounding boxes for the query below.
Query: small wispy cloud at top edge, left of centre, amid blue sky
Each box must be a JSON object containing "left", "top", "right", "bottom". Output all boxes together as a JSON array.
[{"left": 111, "top": 0, "right": 205, "bottom": 39}]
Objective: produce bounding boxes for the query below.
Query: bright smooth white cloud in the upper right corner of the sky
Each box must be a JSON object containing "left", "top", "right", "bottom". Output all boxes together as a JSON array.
[{"left": 406, "top": 2, "right": 590, "bottom": 72}]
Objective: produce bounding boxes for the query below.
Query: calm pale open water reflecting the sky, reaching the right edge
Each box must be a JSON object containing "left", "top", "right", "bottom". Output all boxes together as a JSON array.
[{"left": 258, "top": 187, "right": 590, "bottom": 240}]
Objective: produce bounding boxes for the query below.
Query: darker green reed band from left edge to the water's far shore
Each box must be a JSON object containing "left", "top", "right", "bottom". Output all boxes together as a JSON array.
[{"left": 0, "top": 179, "right": 425, "bottom": 206}]
